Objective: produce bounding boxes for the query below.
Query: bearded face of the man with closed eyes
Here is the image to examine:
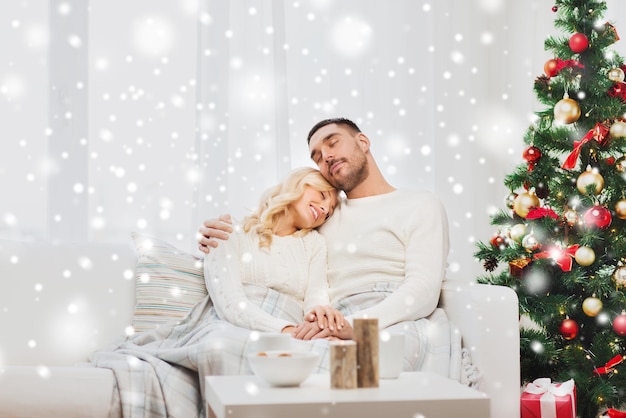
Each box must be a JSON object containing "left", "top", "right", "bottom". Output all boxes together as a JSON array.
[{"left": 309, "top": 124, "right": 369, "bottom": 193}]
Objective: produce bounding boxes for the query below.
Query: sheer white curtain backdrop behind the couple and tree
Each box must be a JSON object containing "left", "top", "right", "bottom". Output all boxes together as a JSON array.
[{"left": 0, "top": 0, "right": 626, "bottom": 280}]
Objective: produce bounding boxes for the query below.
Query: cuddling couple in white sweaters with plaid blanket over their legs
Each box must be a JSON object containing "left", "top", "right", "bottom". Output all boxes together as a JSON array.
[{"left": 90, "top": 119, "right": 450, "bottom": 418}]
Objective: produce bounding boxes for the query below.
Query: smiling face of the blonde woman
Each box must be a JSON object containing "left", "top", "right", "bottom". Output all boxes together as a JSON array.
[{"left": 290, "top": 186, "right": 337, "bottom": 229}]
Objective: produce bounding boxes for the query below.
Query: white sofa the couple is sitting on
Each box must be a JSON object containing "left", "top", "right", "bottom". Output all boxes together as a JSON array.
[{"left": 0, "top": 241, "right": 520, "bottom": 418}]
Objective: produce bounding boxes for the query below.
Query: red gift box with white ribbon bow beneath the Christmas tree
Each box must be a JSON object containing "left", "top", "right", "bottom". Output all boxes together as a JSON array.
[{"left": 521, "top": 378, "right": 576, "bottom": 418}]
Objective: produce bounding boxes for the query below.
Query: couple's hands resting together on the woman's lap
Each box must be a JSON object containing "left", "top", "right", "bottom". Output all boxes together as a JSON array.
[{"left": 292, "top": 305, "right": 352, "bottom": 340}]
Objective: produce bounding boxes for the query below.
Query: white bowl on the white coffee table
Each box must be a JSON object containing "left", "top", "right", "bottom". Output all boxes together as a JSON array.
[{"left": 248, "top": 350, "right": 319, "bottom": 386}]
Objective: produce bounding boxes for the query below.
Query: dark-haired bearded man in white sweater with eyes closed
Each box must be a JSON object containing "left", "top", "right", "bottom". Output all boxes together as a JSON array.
[{"left": 199, "top": 118, "right": 449, "bottom": 370}]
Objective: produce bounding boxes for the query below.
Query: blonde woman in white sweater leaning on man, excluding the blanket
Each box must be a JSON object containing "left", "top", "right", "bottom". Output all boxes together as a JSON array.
[{"left": 204, "top": 168, "right": 343, "bottom": 332}]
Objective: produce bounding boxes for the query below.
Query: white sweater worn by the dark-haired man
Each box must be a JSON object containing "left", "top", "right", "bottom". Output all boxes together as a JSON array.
[{"left": 320, "top": 190, "right": 449, "bottom": 328}]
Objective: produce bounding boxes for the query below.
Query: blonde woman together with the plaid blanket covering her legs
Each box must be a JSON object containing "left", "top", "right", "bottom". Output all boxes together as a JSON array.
[{"left": 90, "top": 168, "right": 344, "bottom": 418}]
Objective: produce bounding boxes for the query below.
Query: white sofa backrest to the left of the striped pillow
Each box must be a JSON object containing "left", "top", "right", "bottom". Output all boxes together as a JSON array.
[{"left": 0, "top": 240, "right": 137, "bottom": 367}]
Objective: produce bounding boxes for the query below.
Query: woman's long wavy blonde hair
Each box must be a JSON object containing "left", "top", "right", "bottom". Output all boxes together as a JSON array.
[{"left": 243, "top": 167, "right": 339, "bottom": 247}]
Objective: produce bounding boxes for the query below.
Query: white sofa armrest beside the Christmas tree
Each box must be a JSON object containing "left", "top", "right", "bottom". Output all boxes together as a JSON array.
[{"left": 440, "top": 280, "right": 521, "bottom": 418}]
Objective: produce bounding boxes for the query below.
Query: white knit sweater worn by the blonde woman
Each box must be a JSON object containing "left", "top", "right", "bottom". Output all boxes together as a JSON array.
[{"left": 204, "top": 225, "right": 329, "bottom": 332}]
